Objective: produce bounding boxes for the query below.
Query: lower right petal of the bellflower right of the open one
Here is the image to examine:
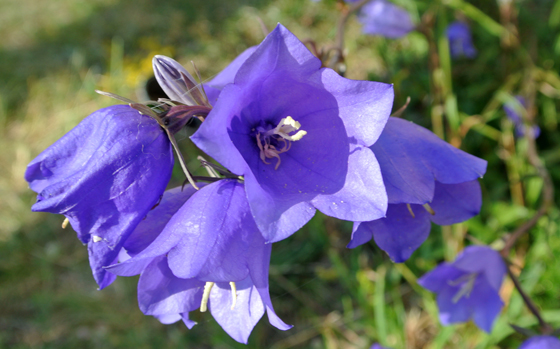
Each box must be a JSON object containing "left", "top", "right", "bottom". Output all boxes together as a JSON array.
[{"left": 430, "top": 179, "right": 482, "bottom": 225}]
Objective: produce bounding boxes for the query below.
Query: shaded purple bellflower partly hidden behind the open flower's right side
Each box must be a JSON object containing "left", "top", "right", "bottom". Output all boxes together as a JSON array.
[{"left": 348, "top": 117, "right": 486, "bottom": 263}]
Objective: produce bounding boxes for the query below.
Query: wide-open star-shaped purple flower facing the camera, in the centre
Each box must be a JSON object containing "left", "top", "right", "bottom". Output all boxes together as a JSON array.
[{"left": 191, "top": 25, "right": 393, "bottom": 242}]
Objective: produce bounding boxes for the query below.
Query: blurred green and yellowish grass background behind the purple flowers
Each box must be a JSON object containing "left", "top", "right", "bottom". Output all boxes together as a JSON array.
[{"left": 0, "top": 0, "right": 560, "bottom": 349}]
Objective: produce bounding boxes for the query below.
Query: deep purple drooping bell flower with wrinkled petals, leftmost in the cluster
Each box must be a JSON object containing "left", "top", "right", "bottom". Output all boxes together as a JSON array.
[{"left": 25, "top": 105, "right": 173, "bottom": 288}]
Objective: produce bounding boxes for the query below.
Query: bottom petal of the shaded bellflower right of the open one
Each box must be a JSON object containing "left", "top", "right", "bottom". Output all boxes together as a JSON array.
[{"left": 350, "top": 204, "right": 431, "bottom": 263}]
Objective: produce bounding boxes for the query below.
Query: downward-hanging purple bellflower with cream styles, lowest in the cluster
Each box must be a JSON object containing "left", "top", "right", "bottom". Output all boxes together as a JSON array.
[{"left": 107, "top": 179, "right": 291, "bottom": 343}]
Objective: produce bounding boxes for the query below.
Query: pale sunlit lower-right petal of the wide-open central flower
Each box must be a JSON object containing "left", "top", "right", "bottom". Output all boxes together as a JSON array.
[{"left": 312, "top": 146, "right": 387, "bottom": 222}]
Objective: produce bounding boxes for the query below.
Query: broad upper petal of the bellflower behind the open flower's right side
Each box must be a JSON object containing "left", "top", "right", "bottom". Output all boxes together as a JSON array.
[{"left": 371, "top": 118, "right": 486, "bottom": 204}]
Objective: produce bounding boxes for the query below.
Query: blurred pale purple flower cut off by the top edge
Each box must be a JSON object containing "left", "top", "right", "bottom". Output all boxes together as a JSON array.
[{"left": 358, "top": 0, "right": 415, "bottom": 39}]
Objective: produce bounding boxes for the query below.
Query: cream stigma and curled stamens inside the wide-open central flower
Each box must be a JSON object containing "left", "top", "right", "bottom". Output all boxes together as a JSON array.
[{"left": 253, "top": 116, "right": 307, "bottom": 170}]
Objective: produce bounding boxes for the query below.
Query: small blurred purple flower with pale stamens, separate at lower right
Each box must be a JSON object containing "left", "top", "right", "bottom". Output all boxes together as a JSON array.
[{"left": 418, "top": 246, "right": 506, "bottom": 332}]
